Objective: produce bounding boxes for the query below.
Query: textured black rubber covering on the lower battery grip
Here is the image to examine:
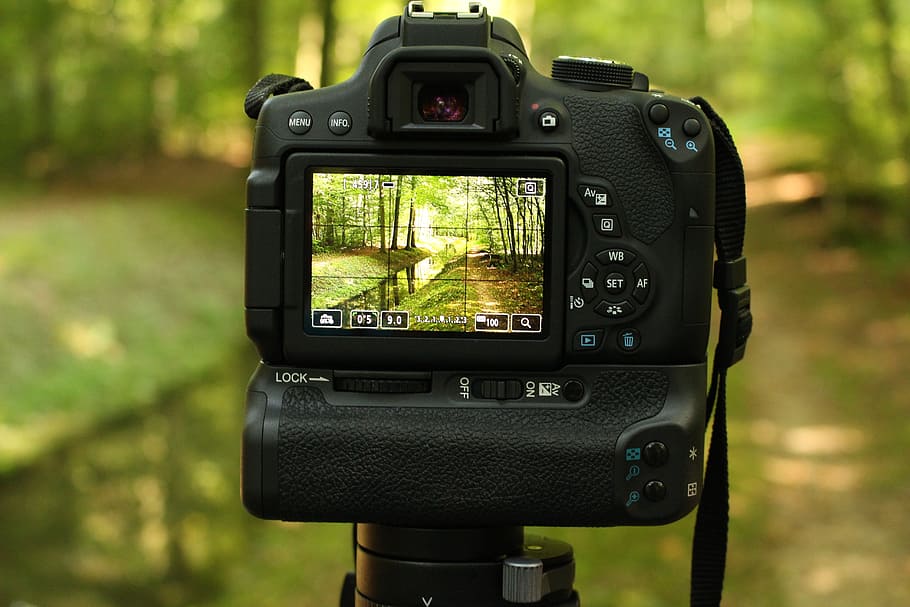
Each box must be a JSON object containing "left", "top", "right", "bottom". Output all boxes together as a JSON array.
[{"left": 276, "top": 370, "right": 670, "bottom": 527}]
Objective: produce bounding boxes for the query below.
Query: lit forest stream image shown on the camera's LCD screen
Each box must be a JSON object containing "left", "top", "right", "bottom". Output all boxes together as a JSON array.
[{"left": 307, "top": 169, "right": 547, "bottom": 337}]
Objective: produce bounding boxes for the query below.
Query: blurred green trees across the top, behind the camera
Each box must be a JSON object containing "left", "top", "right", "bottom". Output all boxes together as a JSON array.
[{"left": 0, "top": 0, "right": 910, "bottom": 234}]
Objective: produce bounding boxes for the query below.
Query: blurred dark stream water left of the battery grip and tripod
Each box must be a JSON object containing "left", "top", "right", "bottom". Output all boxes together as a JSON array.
[{"left": 0, "top": 357, "right": 350, "bottom": 607}]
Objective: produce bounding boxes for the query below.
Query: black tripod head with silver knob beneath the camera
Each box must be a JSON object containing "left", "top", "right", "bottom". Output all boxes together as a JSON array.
[{"left": 340, "top": 524, "right": 580, "bottom": 607}]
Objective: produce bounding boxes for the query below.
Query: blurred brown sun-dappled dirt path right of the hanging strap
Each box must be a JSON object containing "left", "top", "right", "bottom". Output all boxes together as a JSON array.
[{"left": 728, "top": 208, "right": 910, "bottom": 607}]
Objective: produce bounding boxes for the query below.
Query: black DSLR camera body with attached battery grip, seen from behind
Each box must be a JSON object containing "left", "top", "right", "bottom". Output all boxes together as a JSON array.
[{"left": 242, "top": 3, "right": 715, "bottom": 527}]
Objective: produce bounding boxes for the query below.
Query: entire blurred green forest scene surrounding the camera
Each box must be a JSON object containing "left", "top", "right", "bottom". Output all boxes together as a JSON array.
[{"left": 0, "top": 0, "right": 910, "bottom": 607}]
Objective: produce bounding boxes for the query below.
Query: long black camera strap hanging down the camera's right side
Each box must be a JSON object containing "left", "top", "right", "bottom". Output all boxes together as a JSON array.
[{"left": 689, "top": 97, "right": 752, "bottom": 607}]
